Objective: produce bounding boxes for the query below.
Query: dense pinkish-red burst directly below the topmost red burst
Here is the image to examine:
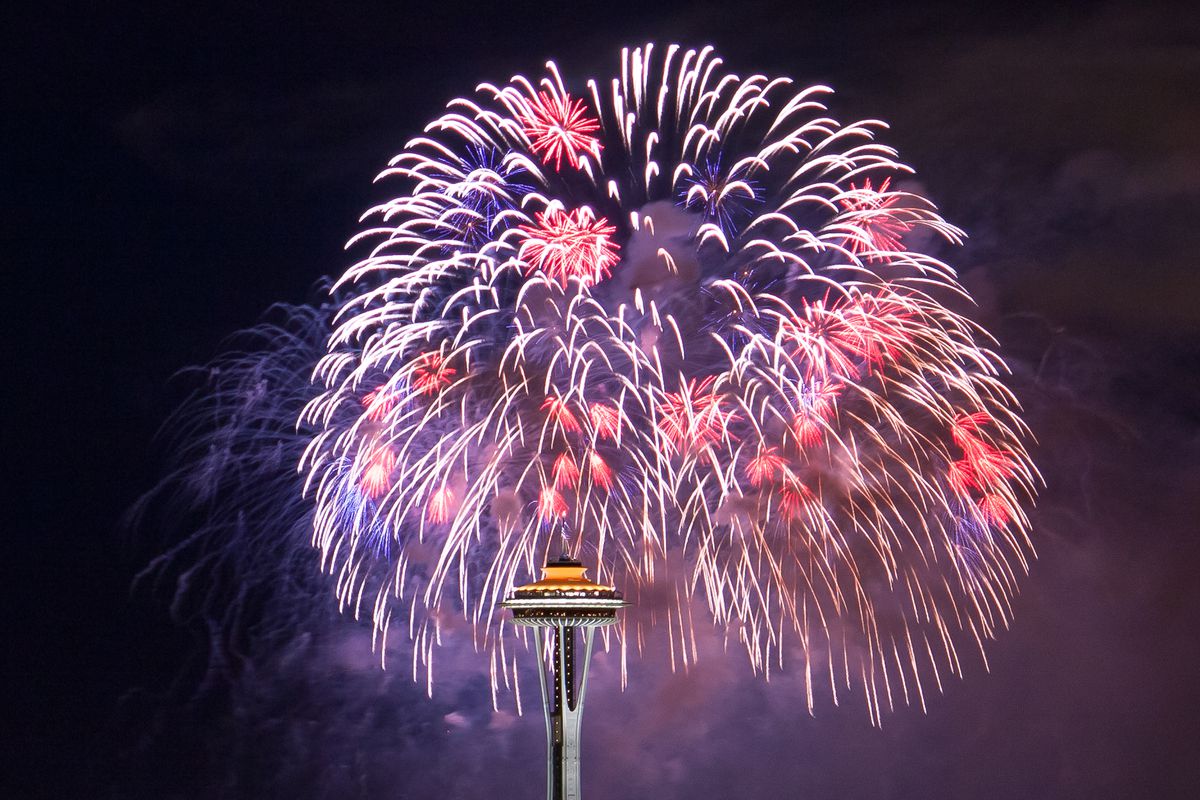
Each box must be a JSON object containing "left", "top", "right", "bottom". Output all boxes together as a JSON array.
[{"left": 521, "top": 209, "right": 620, "bottom": 288}]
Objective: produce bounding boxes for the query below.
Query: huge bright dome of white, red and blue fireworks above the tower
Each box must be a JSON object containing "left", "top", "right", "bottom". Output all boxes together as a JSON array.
[{"left": 302, "top": 46, "right": 1038, "bottom": 716}]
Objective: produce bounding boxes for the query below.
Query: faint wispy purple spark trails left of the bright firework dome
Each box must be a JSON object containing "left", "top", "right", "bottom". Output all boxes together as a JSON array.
[{"left": 127, "top": 303, "right": 336, "bottom": 696}]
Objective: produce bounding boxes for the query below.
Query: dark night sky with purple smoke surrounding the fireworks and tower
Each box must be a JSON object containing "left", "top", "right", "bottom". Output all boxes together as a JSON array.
[{"left": 0, "top": 1, "right": 1200, "bottom": 800}]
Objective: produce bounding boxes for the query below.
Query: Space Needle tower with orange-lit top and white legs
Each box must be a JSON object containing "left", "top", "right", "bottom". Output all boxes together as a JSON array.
[{"left": 502, "top": 554, "right": 628, "bottom": 800}]
